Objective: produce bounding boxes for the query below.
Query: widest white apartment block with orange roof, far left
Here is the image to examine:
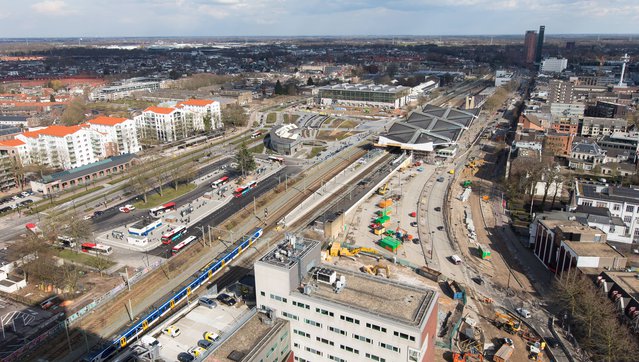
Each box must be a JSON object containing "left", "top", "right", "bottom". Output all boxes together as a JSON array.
[{"left": 16, "top": 125, "right": 99, "bottom": 170}]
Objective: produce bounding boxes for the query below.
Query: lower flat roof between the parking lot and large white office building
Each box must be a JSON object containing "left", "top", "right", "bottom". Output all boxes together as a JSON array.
[{"left": 206, "top": 313, "right": 288, "bottom": 362}]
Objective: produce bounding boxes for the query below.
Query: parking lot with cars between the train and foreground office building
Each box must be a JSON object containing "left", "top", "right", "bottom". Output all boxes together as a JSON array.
[{"left": 156, "top": 296, "right": 249, "bottom": 361}]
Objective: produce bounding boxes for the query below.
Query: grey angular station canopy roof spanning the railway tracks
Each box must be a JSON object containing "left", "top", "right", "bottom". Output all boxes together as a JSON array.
[{"left": 377, "top": 105, "right": 480, "bottom": 152}]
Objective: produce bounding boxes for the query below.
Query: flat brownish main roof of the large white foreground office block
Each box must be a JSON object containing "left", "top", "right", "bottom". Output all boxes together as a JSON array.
[{"left": 298, "top": 264, "right": 436, "bottom": 326}]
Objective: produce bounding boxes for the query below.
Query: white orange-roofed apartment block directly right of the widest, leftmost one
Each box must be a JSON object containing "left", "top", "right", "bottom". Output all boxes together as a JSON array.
[{"left": 87, "top": 116, "right": 141, "bottom": 158}]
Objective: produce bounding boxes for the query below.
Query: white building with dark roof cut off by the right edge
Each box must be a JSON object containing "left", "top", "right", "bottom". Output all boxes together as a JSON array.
[{"left": 571, "top": 181, "right": 639, "bottom": 244}]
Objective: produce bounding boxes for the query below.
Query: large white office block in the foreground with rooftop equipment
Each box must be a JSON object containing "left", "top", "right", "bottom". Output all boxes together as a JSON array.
[{"left": 255, "top": 236, "right": 438, "bottom": 362}]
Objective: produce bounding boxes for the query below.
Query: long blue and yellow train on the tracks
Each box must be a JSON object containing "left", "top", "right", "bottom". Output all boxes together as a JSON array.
[{"left": 84, "top": 228, "right": 264, "bottom": 362}]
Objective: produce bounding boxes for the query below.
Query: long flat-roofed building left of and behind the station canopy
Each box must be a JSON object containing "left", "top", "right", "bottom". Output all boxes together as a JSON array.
[{"left": 318, "top": 83, "right": 411, "bottom": 108}]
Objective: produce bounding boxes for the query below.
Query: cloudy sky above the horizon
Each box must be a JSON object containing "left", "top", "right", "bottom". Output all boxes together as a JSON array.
[{"left": 0, "top": 0, "right": 639, "bottom": 37}]
